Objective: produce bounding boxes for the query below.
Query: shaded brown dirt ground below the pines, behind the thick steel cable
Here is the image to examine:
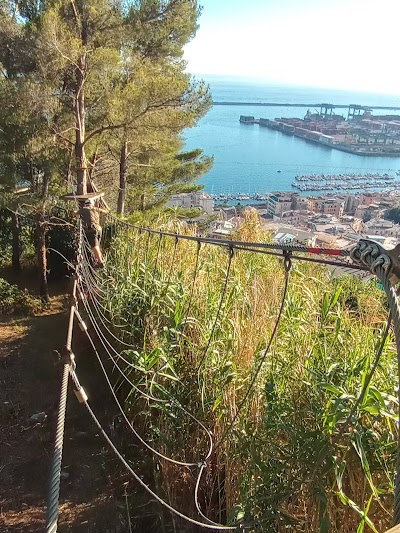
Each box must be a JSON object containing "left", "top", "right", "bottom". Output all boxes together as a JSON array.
[{"left": 0, "top": 297, "right": 127, "bottom": 533}]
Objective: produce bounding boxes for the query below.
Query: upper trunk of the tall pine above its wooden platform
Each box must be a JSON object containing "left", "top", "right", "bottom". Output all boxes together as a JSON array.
[{"left": 75, "top": 55, "right": 87, "bottom": 194}]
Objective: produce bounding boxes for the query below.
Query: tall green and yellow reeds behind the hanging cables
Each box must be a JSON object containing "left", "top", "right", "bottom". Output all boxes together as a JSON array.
[{"left": 94, "top": 210, "right": 398, "bottom": 533}]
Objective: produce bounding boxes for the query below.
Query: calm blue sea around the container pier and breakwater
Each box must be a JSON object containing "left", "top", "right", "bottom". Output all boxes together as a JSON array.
[{"left": 184, "top": 77, "right": 400, "bottom": 194}]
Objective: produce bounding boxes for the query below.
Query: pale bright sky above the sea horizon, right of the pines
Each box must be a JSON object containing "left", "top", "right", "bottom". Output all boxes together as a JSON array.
[{"left": 184, "top": 0, "right": 400, "bottom": 94}]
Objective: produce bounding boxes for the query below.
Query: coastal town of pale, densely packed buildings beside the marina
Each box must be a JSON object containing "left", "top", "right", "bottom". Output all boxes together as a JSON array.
[{"left": 212, "top": 186, "right": 400, "bottom": 266}]
